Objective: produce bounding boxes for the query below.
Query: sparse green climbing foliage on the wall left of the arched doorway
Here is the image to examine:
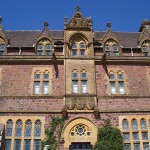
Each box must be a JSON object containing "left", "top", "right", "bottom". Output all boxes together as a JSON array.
[{"left": 41, "top": 117, "right": 64, "bottom": 150}]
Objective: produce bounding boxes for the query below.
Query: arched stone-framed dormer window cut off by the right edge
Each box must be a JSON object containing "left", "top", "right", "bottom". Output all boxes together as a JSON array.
[{"left": 141, "top": 39, "right": 150, "bottom": 57}]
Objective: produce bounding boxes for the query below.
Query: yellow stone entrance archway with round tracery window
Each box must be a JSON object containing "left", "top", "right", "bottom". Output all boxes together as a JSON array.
[{"left": 62, "top": 118, "right": 98, "bottom": 148}]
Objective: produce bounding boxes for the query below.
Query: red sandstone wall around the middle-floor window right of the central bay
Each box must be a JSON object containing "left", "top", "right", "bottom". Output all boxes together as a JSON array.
[{"left": 95, "top": 65, "right": 150, "bottom": 96}]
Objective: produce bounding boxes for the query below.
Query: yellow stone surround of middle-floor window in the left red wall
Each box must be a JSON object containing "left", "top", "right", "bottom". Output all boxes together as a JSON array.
[{"left": 31, "top": 67, "right": 53, "bottom": 96}]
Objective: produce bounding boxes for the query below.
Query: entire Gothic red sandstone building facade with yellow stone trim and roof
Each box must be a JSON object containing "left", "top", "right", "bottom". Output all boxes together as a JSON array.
[{"left": 0, "top": 7, "right": 150, "bottom": 150}]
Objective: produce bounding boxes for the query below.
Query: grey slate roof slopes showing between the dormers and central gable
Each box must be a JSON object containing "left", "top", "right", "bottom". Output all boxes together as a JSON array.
[{"left": 6, "top": 30, "right": 141, "bottom": 48}]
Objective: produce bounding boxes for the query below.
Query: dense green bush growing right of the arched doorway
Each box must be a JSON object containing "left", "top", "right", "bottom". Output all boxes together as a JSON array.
[{"left": 93, "top": 120, "right": 124, "bottom": 150}]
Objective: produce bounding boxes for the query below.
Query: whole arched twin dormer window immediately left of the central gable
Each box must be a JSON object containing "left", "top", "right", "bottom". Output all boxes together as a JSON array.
[{"left": 37, "top": 39, "right": 52, "bottom": 55}]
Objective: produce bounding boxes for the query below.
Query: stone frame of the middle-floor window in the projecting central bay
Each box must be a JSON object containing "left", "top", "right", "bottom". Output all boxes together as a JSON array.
[{"left": 71, "top": 69, "right": 88, "bottom": 94}]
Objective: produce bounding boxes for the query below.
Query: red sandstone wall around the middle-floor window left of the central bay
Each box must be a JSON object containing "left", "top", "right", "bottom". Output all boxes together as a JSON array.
[{"left": 0, "top": 63, "right": 64, "bottom": 96}]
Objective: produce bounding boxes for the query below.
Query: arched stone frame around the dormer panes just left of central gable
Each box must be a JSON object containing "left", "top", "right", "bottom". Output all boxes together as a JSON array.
[{"left": 36, "top": 38, "right": 54, "bottom": 56}]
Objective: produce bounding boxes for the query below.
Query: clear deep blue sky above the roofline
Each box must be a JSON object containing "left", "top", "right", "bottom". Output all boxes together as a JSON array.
[{"left": 0, "top": 0, "right": 150, "bottom": 32}]
